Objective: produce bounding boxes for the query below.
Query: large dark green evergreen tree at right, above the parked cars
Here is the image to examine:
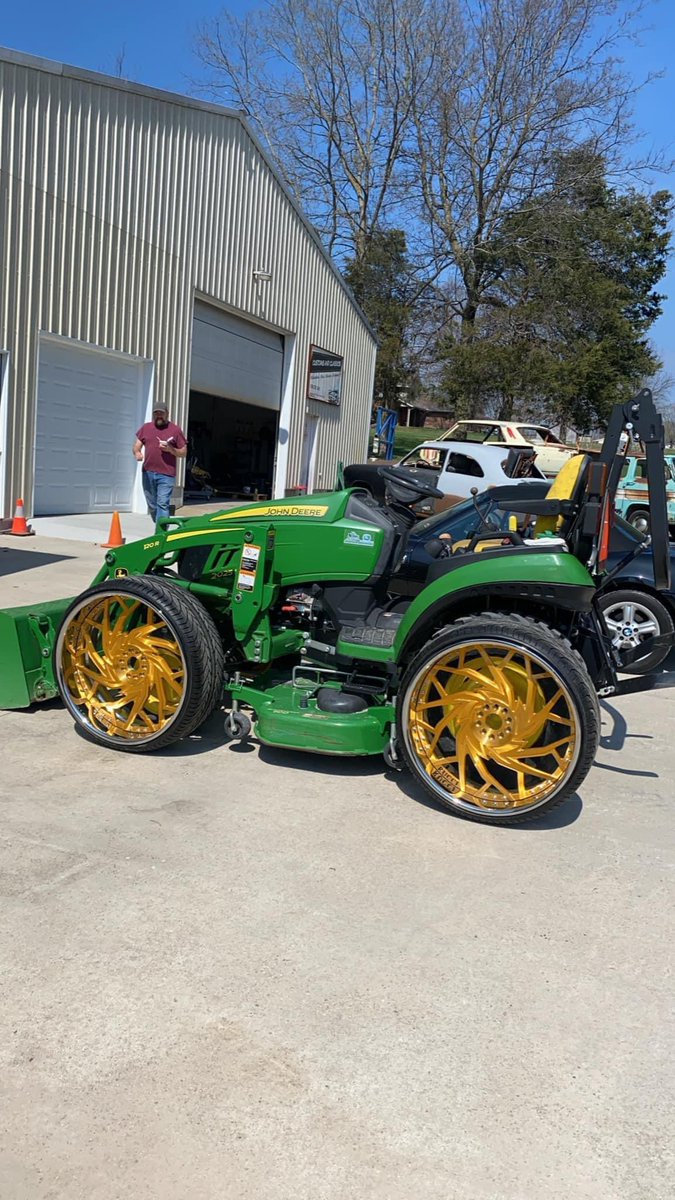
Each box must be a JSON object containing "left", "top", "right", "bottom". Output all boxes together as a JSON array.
[{"left": 441, "top": 151, "right": 673, "bottom": 428}]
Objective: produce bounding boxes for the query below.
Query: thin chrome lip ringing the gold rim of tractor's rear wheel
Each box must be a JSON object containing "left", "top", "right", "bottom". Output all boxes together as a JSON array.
[{"left": 401, "top": 636, "right": 581, "bottom": 823}]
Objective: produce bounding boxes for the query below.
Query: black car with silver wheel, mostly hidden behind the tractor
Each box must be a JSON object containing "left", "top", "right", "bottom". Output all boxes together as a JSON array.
[{"left": 393, "top": 480, "right": 675, "bottom": 674}]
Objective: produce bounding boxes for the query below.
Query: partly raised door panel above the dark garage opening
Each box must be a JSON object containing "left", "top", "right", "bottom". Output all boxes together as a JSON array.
[{"left": 190, "top": 300, "right": 283, "bottom": 409}]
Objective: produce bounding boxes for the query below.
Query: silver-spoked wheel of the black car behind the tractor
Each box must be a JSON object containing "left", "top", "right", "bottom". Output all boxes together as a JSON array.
[{"left": 599, "top": 588, "right": 675, "bottom": 674}]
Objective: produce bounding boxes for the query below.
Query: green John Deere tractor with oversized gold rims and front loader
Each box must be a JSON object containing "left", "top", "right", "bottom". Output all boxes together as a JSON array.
[{"left": 0, "top": 392, "right": 669, "bottom": 824}]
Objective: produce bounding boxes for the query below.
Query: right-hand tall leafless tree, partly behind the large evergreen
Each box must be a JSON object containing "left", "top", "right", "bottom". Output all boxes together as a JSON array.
[{"left": 414, "top": 0, "right": 658, "bottom": 338}]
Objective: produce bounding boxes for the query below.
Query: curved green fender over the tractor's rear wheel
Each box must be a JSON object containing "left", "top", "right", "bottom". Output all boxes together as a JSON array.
[{"left": 394, "top": 550, "right": 596, "bottom": 661}]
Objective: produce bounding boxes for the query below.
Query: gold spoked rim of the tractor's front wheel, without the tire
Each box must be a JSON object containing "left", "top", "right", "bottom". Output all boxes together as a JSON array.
[{"left": 56, "top": 593, "right": 185, "bottom": 742}]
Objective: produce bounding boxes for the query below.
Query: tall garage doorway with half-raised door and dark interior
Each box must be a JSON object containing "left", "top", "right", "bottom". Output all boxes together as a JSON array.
[{"left": 185, "top": 300, "right": 283, "bottom": 500}]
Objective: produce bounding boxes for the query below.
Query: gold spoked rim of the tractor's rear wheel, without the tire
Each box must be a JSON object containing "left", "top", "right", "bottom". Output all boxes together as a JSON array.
[{"left": 404, "top": 642, "right": 579, "bottom": 811}]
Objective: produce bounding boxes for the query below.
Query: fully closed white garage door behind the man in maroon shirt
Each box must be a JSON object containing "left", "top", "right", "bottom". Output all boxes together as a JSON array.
[{"left": 34, "top": 337, "right": 149, "bottom": 516}]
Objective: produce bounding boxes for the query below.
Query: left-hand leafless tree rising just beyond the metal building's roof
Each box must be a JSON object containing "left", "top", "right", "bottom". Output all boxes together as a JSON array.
[{"left": 197, "top": 0, "right": 446, "bottom": 258}]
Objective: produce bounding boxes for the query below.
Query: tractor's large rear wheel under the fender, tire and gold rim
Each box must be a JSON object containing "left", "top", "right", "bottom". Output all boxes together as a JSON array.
[{"left": 396, "top": 613, "right": 601, "bottom": 826}]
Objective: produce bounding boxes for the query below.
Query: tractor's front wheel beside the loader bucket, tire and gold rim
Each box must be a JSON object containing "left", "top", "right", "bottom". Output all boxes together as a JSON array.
[{"left": 54, "top": 575, "right": 225, "bottom": 754}]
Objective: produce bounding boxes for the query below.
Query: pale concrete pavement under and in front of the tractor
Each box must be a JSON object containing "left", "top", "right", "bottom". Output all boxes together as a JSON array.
[{"left": 0, "top": 539, "right": 675, "bottom": 1200}]
